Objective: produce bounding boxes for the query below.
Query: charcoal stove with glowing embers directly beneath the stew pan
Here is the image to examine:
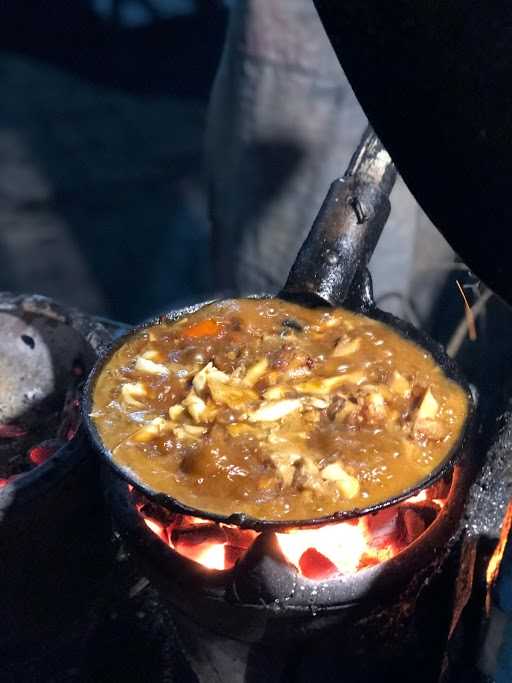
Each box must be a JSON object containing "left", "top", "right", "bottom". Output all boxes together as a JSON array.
[{"left": 104, "top": 444, "right": 480, "bottom": 681}]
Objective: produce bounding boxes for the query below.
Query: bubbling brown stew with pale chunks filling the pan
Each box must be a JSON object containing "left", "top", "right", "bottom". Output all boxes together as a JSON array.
[{"left": 92, "top": 299, "right": 468, "bottom": 521}]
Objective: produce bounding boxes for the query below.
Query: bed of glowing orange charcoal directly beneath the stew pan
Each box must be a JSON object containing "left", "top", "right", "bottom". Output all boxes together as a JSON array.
[{"left": 133, "top": 483, "right": 449, "bottom": 581}]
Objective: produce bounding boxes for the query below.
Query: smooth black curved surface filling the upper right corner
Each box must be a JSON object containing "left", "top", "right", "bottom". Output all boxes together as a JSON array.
[{"left": 314, "top": 0, "right": 512, "bottom": 303}]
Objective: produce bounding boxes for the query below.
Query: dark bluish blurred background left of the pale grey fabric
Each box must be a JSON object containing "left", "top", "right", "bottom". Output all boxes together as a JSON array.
[{"left": 0, "top": 0, "right": 228, "bottom": 322}]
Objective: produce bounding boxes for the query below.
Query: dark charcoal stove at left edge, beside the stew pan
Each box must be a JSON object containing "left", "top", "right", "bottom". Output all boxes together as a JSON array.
[{"left": 0, "top": 293, "right": 111, "bottom": 680}]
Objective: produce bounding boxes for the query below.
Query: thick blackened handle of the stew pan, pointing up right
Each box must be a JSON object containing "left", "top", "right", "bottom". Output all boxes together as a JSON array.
[{"left": 281, "top": 126, "right": 397, "bottom": 309}]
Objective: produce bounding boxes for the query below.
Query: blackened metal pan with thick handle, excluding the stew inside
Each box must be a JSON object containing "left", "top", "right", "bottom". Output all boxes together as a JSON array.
[{"left": 82, "top": 131, "right": 475, "bottom": 529}]
